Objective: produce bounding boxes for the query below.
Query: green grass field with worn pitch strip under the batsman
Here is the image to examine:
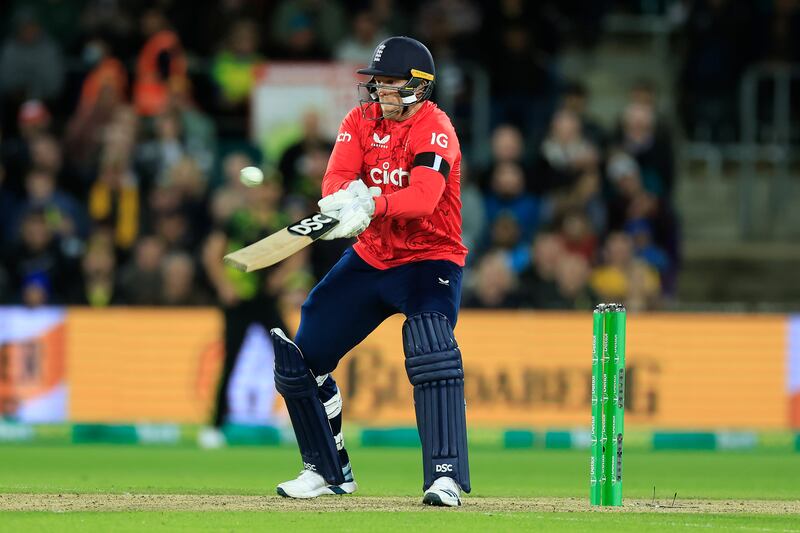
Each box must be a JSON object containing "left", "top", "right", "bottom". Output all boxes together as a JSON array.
[{"left": 0, "top": 445, "right": 800, "bottom": 533}]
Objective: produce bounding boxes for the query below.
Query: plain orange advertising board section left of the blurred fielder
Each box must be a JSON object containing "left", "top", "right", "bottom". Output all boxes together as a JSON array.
[{"left": 66, "top": 308, "right": 222, "bottom": 423}]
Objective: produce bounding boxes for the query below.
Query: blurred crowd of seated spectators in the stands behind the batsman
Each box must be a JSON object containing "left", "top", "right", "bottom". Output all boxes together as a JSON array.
[{"left": 0, "top": 0, "right": 798, "bottom": 309}]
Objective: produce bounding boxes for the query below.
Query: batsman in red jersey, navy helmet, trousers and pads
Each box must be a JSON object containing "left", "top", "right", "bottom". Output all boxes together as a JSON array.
[{"left": 271, "top": 37, "right": 470, "bottom": 506}]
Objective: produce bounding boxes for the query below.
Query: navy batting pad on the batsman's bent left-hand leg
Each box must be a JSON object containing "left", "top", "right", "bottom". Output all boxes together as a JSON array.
[{"left": 270, "top": 328, "right": 344, "bottom": 485}]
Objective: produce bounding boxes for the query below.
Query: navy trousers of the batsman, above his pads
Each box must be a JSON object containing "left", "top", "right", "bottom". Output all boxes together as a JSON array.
[{"left": 295, "top": 248, "right": 462, "bottom": 376}]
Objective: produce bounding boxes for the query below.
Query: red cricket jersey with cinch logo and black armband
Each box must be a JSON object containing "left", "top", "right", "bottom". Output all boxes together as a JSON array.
[{"left": 322, "top": 101, "right": 467, "bottom": 269}]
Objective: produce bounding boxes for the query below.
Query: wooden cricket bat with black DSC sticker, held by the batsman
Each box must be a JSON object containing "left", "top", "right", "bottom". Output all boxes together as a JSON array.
[{"left": 223, "top": 213, "right": 339, "bottom": 272}]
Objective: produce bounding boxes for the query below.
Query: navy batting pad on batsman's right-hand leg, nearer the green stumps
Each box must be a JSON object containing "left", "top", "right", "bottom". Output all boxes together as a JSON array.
[{"left": 403, "top": 312, "right": 470, "bottom": 492}]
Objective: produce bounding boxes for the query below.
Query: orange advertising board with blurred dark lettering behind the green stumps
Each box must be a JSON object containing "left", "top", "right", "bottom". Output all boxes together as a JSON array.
[{"left": 334, "top": 312, "right": 789, "bottom": 429}]
